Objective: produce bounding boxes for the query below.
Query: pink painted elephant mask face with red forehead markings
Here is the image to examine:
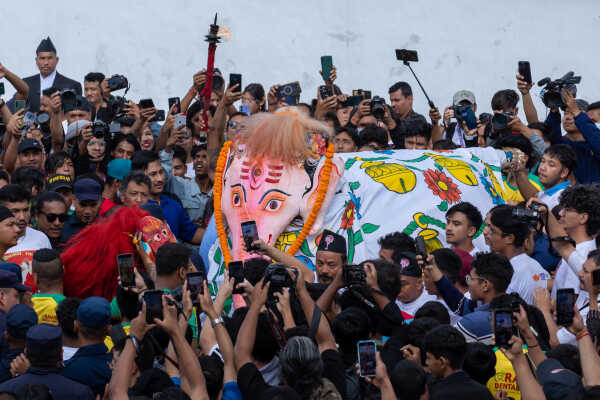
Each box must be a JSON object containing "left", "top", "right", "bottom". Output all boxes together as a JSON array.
[{"left": 221, "top": 149, "right": 341, "bottom": 260}]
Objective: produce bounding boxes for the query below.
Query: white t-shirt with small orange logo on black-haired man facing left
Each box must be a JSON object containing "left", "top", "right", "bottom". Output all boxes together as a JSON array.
[{"left": 506, "top": 253, "right": 550, "bottom": 304}]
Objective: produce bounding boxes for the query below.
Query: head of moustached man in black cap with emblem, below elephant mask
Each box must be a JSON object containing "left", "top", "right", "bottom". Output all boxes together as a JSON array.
[{"left": 316, "top": 229, "right": 347, "bottom": 285}]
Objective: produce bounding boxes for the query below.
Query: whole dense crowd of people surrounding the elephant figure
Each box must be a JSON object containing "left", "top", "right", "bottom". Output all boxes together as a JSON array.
[{"left": 0, "top": 38, "right": 600, "bottom": 400}]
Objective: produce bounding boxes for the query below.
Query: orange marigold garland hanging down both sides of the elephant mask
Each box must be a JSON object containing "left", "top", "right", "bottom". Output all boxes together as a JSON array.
[{"left": 213, "top": 142, "right": 335, "bottom": 268}]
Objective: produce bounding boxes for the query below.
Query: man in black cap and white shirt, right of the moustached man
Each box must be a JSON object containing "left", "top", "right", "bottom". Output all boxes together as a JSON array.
[{"left": 394, "top": 253, "right": 439, "bottom": 318}]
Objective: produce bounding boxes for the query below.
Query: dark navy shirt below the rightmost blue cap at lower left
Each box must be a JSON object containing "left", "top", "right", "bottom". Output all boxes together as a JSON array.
[{"left": 63, "top": 343, "right": 112, "bottom": 396}]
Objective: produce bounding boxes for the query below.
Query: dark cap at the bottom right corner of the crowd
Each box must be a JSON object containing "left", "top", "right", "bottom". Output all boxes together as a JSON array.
[{"left": 536, "top": 358, "right": 583, "bottom": 400}]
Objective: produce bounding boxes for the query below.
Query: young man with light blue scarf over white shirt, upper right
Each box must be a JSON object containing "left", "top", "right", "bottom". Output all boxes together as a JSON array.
[{"left": 510, "top": 144, "right": 577, "bottom": 211}]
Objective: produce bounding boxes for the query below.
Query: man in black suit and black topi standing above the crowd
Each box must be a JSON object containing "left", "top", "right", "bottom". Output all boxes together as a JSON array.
[{"left": 9, "top": 37, "right": 81, "bottom": 112}]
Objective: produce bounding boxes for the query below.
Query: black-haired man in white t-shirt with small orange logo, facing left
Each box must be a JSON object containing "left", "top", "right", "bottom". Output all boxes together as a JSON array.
[{"left": 489, "top": 206, "right": 550, "bottom": 304}]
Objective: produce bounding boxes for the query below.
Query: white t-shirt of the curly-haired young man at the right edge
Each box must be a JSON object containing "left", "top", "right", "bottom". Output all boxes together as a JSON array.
[{"left": 552, "top": 239, "right": 596, "bottom": 307}]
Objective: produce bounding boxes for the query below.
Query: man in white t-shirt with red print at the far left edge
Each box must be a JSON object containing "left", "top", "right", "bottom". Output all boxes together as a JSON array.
[{"left": 0, "top": 184, "right": 52, "bottom": 279}]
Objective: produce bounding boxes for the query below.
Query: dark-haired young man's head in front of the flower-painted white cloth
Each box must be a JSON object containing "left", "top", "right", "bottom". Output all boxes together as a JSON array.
[{"left": 446, "top": 202, "right": 483, "bottom": 257}]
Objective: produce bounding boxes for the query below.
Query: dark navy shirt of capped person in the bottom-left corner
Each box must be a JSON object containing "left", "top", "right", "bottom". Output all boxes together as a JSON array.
[{"left": 0, "top": 367, "right": 94, "bottom": 400}]
